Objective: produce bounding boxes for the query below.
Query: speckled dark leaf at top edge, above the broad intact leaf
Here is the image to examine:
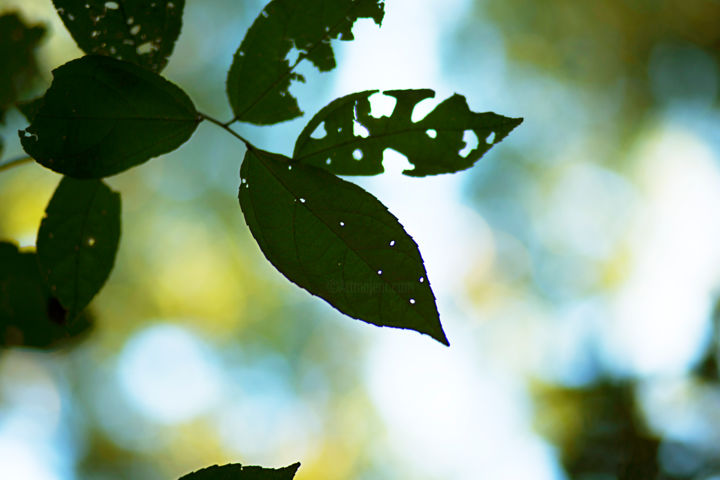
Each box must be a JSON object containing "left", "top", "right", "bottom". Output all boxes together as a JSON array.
[{"left": 53, "top": 0, "right": 185, "bottom": 72}]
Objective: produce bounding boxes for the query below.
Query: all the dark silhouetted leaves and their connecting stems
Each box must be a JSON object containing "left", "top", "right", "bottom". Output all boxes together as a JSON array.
[{"left": 0, "top": 0, "right": 522, "bottom": 474}]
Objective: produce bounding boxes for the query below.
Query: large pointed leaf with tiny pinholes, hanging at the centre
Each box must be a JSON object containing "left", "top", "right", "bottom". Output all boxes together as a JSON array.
[{"left": 239, "top": 149, "right": 448, "bottom": 345}]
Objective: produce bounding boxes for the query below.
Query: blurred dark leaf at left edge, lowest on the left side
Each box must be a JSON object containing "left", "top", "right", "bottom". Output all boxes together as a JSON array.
[{"left": 0, "top": 242, "right": 92, "bottom": 348}]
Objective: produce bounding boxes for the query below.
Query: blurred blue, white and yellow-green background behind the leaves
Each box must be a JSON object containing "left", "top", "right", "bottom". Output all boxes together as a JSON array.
[{"left": 0, "top": 0, "right": 720, "bottom": 480}]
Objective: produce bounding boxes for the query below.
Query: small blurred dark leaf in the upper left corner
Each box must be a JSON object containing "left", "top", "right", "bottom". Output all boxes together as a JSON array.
[{"left": 0, "top": 13, "right": 45, "bottom": 123}]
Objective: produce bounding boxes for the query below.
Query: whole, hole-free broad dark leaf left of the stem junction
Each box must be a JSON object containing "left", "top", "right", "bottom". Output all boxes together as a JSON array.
[{"left": 19, "top": 56, "right": 201, "bottom": 178}]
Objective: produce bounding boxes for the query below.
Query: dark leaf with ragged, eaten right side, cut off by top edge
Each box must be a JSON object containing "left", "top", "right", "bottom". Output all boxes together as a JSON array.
[{"left": 227, "top": 0, "right": 384, "bottom": 125}]
